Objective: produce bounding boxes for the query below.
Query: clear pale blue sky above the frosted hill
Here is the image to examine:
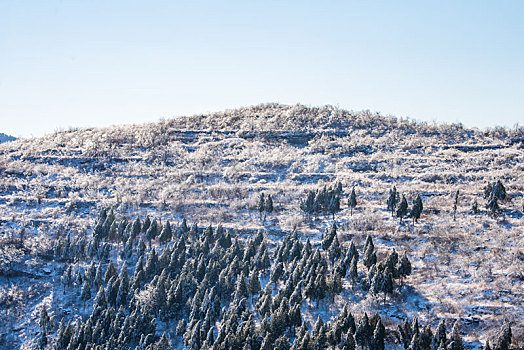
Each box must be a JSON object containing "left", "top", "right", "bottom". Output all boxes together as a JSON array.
[{"left": 0, "top": 0, "right": 524, "bottom": 136}]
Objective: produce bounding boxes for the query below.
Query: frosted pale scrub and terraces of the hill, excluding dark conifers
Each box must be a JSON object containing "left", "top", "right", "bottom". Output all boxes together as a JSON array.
[{"left": 0, "top": 104, "right": 524, "bottom": 347}]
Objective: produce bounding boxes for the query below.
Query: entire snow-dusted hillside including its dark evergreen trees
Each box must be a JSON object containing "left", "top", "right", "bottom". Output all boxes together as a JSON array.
[{"left": 0, "top": 104, "right": 524, "bottom": 350}]
